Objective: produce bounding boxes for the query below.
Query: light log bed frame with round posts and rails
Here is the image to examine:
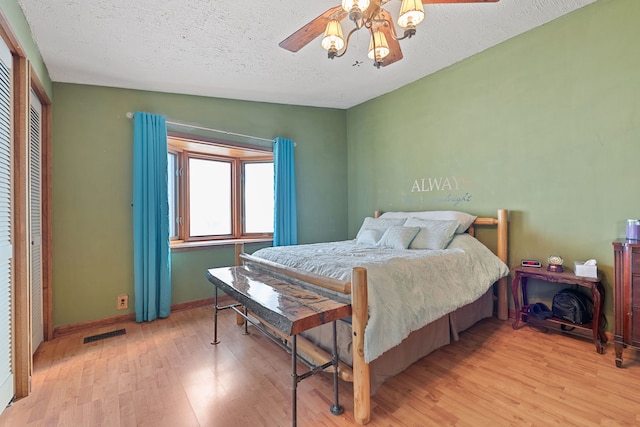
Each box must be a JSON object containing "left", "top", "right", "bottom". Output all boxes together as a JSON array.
[{"left": 235, "top": 209, "right": 508, "bottom": 425}]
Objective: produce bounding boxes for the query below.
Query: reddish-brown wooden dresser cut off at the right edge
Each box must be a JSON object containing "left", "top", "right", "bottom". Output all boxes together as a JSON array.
[{"left": 613, "top": 239, "right": 640, "bottom": 368}]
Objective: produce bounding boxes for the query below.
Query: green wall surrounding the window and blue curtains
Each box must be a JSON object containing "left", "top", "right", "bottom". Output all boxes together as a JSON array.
[{"left": 52, "top": 83, "right": 347, "bottom": 326}]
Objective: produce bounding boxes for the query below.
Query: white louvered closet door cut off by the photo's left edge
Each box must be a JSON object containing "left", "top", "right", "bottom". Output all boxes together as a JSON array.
[{"left": 0, "top": 38, "right": 15, "bottom": 413}]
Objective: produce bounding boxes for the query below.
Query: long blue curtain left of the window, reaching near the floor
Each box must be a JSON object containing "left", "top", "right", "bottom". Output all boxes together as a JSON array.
[{"left": 133, "top": 112, "right": 171, "bottom": 322}]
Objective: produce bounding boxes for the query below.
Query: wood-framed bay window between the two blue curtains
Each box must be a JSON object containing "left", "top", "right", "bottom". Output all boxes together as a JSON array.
[{"left": 168, "top": 136, "right": 274, "bottom": 243}]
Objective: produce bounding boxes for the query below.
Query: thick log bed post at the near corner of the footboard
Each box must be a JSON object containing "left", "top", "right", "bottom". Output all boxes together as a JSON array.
[{"left": 351, "top": 267, "right": 371, "bottom": 424}]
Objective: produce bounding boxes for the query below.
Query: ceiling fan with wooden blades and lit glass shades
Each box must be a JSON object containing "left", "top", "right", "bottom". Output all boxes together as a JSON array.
[{"left": 280, "top": 0, "right": 500, "bottom": 68}]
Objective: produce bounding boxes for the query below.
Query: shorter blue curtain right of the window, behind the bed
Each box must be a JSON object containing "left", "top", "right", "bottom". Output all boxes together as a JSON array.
[{"left": 273, "top": 138, "right": 298, "bottom": 246}]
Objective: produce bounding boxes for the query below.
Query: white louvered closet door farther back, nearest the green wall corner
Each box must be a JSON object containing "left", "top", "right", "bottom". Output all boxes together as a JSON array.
[{"left": 29, "top": 91, "right": 44, "bottom": 353}]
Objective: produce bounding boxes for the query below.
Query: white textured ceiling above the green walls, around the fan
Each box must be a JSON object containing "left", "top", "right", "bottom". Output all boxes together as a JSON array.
[{"left": 18, "top": 0, "right": 595, "bottom": 108}]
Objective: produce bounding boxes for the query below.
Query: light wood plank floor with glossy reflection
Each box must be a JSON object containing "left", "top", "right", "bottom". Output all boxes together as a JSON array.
[{"left": 0, "top": 307, "right": 640, "bottom": 427}]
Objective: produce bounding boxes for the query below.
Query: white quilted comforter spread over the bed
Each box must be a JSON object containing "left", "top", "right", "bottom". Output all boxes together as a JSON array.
[{"left": 253, "top": 234, "right": 509, "bottom": 362}]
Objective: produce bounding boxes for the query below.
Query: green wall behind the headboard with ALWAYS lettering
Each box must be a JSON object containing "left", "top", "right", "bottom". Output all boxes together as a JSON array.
[{"left": 347, "top": 0, "right": 640, "bottom": 329}]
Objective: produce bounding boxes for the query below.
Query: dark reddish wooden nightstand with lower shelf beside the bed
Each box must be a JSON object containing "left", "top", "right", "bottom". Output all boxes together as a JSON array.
[{"left": 511, "top": 267, "right": 607, "bottom": 354}]
